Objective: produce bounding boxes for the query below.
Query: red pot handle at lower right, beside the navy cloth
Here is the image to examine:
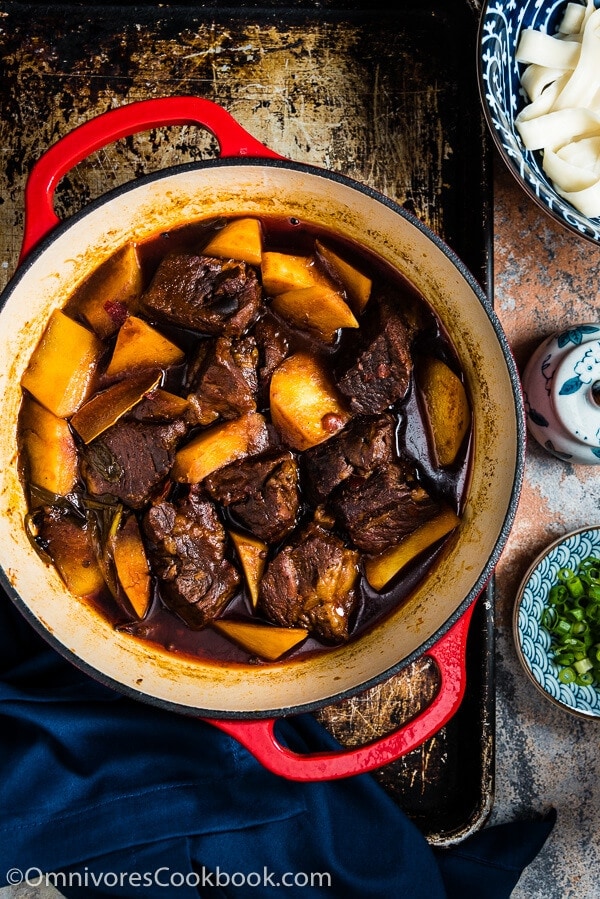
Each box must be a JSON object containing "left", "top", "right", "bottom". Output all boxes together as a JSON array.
[{"left": 206, "top": 603, "right": 475, "bottom": 781}]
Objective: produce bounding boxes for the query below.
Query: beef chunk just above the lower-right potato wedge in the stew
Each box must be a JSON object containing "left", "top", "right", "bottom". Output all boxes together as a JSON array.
[{"left": 330, "top": 462, "right": 439, "bottom": 553}]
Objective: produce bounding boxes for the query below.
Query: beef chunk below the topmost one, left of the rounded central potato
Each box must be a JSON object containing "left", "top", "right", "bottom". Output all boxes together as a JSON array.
[{"left": 186, "top": 337, "right": 258, "bottom": 425}]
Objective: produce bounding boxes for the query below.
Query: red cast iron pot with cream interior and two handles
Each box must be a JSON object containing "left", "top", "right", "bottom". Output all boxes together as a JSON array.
[{"left": 0, "top": 97, "right": 524, "bottom": 779}]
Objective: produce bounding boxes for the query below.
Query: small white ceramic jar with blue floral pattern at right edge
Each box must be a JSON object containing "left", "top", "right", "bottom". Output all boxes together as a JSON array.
[{"left": 522, "top": 322, "right": 600, "bottom": 465}]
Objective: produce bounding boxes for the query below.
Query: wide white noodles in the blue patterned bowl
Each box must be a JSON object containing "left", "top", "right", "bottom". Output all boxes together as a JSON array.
[{"left": 515, "top": 0, "right": 600, "bottom": 218}]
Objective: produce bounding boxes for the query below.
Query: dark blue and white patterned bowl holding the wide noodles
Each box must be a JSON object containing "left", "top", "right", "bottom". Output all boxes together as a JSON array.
[{"left": 479, "top": 0, "right": 600, "bottom": 242}]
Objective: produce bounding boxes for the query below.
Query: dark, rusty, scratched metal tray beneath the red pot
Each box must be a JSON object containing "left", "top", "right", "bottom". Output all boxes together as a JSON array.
[{"left": 0, "top": 0, "right": 494, "bottom": 845}]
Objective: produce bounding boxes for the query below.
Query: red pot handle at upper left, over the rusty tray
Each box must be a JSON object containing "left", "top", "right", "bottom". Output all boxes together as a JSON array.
[{"left": 19, "top": 96, "right": 284, "bottom": 261}]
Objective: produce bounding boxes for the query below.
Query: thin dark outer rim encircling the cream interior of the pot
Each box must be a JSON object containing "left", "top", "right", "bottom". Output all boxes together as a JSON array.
[{"left": 0, "top": 157, "right": 526, "bottom": 720}]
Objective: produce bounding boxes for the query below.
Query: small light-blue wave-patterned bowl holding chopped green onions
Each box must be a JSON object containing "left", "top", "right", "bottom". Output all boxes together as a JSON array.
[{"left": 513, "top": 526, "right": 600, "bottom": 718}]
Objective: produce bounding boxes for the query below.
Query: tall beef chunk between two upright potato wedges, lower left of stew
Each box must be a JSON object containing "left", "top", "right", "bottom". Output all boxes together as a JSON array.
[{"left": 142, "top": 486, "right": 240, "bottom": 630}]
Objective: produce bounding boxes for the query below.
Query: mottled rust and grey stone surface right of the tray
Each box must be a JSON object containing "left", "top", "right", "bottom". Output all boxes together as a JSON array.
[{"left": 490, "top": 162, "right": 600, "bottom": 899}]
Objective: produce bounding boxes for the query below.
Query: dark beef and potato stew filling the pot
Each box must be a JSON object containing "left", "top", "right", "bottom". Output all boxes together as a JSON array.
[{"left": 19, "top": 218, "right": 470, "bottom": 664}]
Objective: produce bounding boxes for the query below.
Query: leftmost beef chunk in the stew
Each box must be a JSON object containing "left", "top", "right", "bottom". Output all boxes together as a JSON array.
[{"left": 81, "top": 419, "right": 188, "bottom": 509}]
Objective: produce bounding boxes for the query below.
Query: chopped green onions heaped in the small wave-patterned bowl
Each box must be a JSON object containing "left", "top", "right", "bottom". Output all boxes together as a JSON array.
[{"left": 541, "top": 556, "right": 600, "bottom": 687}]
